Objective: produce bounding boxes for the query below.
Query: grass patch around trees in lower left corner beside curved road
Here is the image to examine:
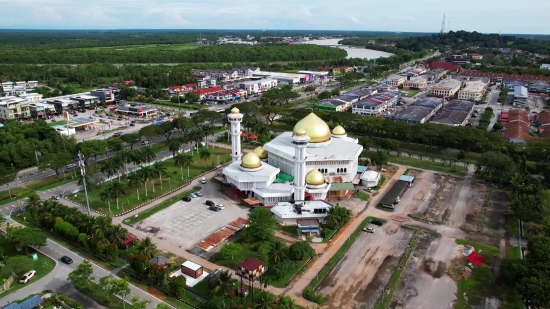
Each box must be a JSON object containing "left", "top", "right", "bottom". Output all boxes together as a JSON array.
[{"left": 0, "top": 236, "right": 56, "bottom": 299}]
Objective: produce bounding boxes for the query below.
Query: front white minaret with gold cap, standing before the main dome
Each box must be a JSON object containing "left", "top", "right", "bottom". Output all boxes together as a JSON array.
[{"left": 292, "top": 128, "right": 309, "bottom": 204}]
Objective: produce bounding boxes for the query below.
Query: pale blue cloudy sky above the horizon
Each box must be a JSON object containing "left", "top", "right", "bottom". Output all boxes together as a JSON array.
[{"left": 0, "top": 0, "right": 550, "bottom": 34}]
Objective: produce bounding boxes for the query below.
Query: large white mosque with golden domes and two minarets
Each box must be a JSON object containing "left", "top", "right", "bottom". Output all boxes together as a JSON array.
[{"left": 222, "top": 108, "right": 363, "bottom": 212}]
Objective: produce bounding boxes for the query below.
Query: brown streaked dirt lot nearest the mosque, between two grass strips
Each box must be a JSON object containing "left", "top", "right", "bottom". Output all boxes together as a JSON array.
[{"left": 315, "top": 222, "right": 414, "bottom": 308}]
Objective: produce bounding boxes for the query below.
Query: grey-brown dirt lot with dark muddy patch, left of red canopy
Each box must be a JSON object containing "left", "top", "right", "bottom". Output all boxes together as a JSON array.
[{"left": 390, "top": 234, "right": 462, "bottom": 309}]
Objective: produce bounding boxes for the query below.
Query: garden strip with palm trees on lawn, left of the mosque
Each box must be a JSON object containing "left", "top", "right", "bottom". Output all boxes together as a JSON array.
[{"left": 68, "top": 147, "right": 230, "bottom": 214}]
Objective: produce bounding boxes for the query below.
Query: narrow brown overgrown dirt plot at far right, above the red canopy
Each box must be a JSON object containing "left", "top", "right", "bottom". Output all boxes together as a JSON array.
[{"left": 483, "top": 188, "right": 508, "bottom": 237}]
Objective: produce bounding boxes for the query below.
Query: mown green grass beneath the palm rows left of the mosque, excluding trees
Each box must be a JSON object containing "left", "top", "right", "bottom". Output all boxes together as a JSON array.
[{"left": 71, "top": 148, "right": 230, "bottom": 214}]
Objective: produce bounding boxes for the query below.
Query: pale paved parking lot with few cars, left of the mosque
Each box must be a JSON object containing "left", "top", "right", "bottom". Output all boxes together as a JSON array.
[{"left": 136, "top": 180, "right": 249, "bottom": 249}]
